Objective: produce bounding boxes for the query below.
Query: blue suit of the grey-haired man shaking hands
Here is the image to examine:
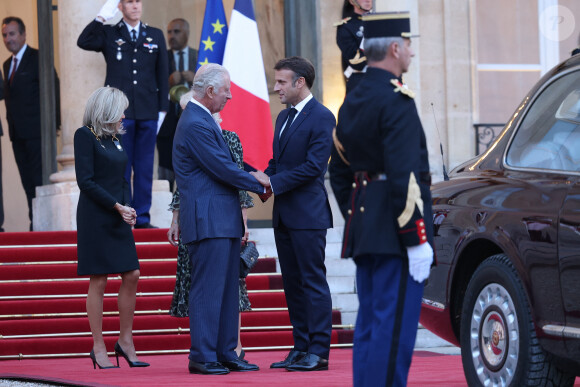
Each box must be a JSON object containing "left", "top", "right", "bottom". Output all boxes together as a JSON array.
[{"left": 173, "top": 102, "right": 264, "bottom": 363}]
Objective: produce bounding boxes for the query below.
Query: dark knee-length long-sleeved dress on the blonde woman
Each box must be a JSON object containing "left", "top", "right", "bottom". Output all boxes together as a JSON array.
[{"left": 74, "top": 126, "right": 139, "bottom": 275}]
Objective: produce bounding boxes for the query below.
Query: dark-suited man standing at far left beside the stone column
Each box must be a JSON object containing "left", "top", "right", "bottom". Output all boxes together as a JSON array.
[{"left": 2, "top": 16, "right": 60, "bottom": 230}]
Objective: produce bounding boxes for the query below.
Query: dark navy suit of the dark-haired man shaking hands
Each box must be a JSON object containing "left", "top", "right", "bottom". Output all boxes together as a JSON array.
[{"left": 265, "top": 98, "right": 336, "bottom": 359}]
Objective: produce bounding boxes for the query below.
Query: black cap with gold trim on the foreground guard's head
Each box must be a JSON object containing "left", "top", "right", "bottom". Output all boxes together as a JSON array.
[{"left": 362, "top": 12, "right": 419, "bottom": 39}]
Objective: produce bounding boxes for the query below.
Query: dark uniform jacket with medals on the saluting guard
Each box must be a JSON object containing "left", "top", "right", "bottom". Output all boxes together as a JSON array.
[{"left": 77, "top": 20, "right": 169, "bottom": 120}]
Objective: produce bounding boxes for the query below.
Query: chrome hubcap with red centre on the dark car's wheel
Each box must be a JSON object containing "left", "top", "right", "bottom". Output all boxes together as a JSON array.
[{"left": 470, "top": 284, "right": 519, "bottom": 386}]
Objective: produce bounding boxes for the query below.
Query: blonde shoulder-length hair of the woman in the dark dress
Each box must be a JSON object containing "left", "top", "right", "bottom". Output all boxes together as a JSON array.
[{"left": 83, "top": 87, "right": 129, "bottom": 137}]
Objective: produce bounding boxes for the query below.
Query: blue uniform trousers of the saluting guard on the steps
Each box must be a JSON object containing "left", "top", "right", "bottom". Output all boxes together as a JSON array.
[{"left": 121, "top": 119, "right": 157, "bottom": 225}]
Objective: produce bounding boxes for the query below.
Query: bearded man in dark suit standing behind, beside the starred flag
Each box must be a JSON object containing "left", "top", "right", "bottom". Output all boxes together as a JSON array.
[{"left": 157, "top": 19, "right": 197, "bottom": 191}]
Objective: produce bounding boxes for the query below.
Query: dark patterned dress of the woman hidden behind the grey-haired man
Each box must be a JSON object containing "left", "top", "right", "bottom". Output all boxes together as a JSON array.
[{"left": 169, "top": 130, "right": 254, "bottom": 317}]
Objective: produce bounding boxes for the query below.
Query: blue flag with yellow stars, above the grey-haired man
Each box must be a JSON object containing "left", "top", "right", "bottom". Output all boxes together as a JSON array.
[{"left": 196, "top": 0, "right": 228, "bottom": 70}]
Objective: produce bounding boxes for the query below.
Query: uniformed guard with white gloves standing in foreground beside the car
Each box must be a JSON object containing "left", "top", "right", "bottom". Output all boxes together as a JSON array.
[{"left": 329, "top": 13, "right": 433, "bottom": 386}]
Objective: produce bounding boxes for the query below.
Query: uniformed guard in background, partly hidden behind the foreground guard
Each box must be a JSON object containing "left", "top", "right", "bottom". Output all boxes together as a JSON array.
[{"left": 334, "top": 0, "right": 373, "bottom": 94}]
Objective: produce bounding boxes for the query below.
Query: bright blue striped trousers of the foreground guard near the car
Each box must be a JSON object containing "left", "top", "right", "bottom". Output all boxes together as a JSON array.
[{"left": 353, "top": 255, "right": 423, "bottom": 387}]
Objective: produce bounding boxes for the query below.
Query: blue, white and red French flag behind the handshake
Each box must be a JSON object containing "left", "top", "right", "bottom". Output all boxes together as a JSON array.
[{"left": 221, "top": 0, "right": 274, "bottom": 170}]
